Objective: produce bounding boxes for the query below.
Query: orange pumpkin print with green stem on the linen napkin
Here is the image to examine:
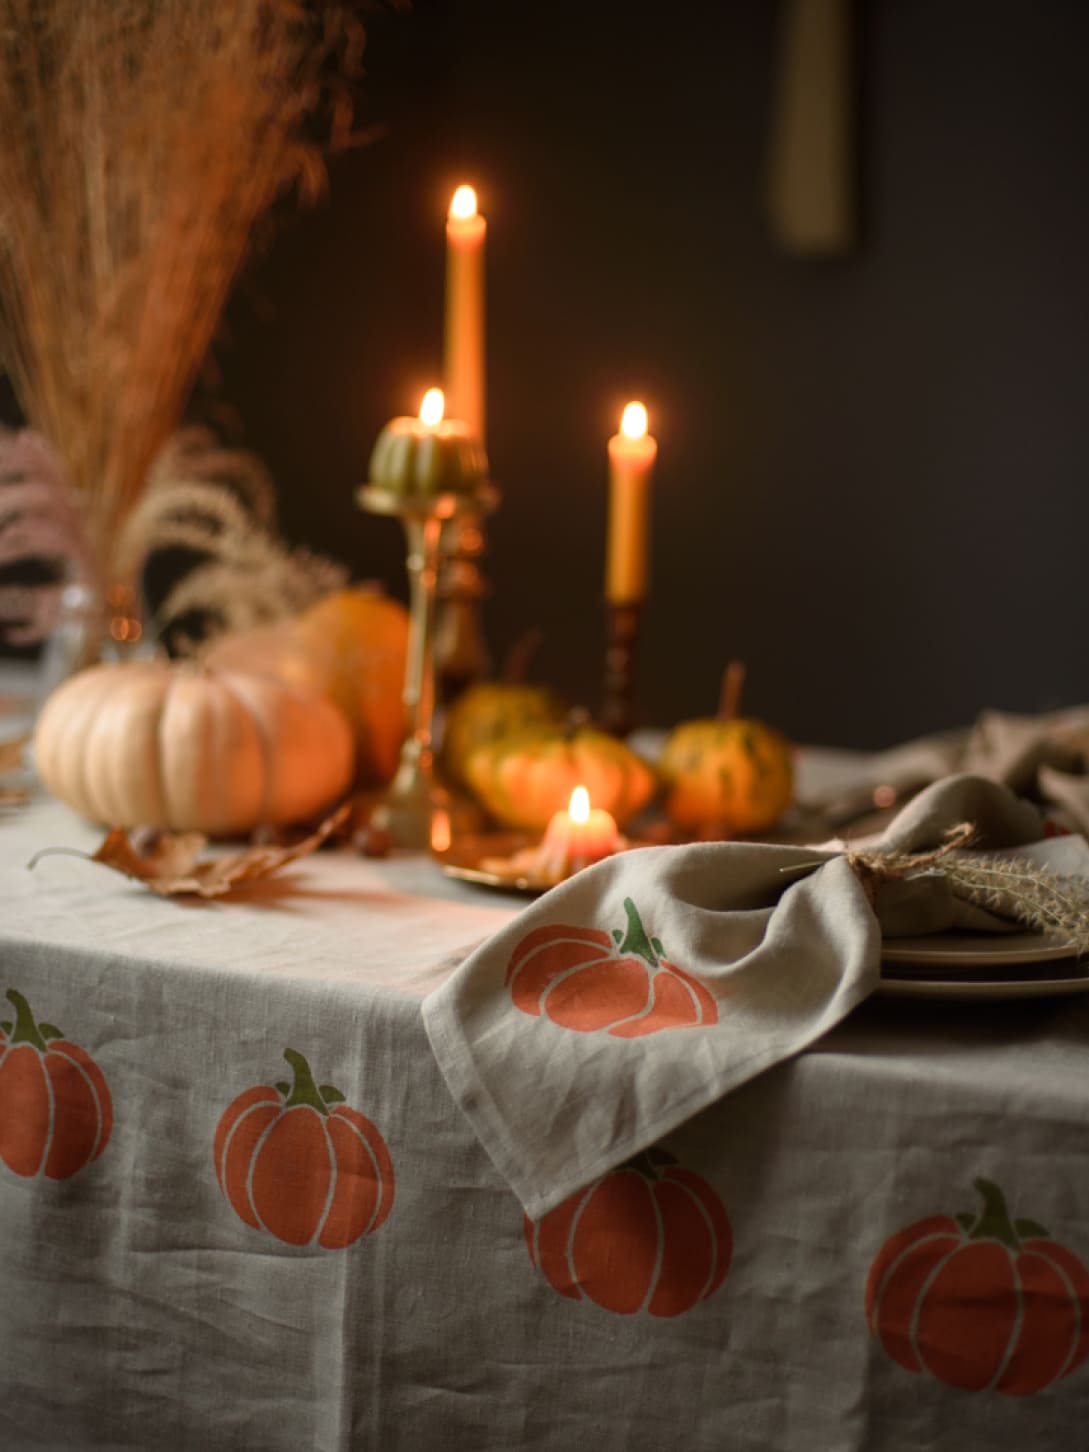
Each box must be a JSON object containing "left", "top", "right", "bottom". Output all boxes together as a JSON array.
[{"left": 507, "top": 897, "right": 719, "bottom": 1038}]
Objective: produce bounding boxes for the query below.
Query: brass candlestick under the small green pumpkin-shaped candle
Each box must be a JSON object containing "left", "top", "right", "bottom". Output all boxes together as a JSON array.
[{"left": 356, "top": 482, "right": 498, "bottom": 849}]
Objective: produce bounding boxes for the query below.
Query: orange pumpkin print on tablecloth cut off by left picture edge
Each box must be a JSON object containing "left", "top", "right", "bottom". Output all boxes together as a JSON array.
[{"left": 0, "top": 989, "right": 113, "bottom": 1179}]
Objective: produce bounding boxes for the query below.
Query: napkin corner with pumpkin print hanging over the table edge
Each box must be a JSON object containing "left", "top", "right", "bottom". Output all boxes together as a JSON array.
[{"left": 423, "top": 842, "right": 880, "bottom": 1218}]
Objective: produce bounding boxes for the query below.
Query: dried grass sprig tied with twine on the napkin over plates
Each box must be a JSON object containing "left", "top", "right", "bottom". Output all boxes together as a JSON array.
[{"left": 847, "top": 822, "right": 1089, "bottom": 957}]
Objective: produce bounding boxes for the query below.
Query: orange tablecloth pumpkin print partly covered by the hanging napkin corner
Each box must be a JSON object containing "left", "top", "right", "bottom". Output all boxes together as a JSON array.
[{"left": 523, "top": 1150, "right": 733, "bottom": 1316}]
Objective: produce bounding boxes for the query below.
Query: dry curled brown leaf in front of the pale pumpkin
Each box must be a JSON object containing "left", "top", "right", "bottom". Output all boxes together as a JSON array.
[{"left": 26, "top": 803, "right": 350, "bottom": 897}]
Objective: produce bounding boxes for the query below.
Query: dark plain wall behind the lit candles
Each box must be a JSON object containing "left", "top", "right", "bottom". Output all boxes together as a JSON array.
[{"left": 4, "top": 0, "right": 1089, "bottom": 746}]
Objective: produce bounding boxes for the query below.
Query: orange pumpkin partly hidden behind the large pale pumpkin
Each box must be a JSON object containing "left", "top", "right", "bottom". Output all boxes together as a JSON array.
[{"left": 206, "top": 588, "right": 408, "bottom": 787}]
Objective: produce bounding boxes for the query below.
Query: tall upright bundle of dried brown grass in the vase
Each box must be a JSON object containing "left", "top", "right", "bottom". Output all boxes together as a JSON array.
[{"left": 0, "top": 0, "right": 363, "bottom": 582}]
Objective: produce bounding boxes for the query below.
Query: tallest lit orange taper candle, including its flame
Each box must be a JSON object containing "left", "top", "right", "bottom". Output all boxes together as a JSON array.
[{"left": 443, "top": 186, "right": 488, "bottom": 443}]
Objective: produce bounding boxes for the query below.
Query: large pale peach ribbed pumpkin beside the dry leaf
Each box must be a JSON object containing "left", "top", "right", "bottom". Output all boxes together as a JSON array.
[{"left": 33, "top": 661, "right": 354, "bottom": 836}]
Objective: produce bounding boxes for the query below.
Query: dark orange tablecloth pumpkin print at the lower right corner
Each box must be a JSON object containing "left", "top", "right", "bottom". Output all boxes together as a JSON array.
[{"left": 865, "top": 1179, "right": 1089, "bottom": 1397}]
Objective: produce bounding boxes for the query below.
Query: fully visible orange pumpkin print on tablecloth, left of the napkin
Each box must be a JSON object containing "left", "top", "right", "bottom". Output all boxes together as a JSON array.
[{"left": 215, "top": 1048, "right": 393, "bottom": 1250}]
